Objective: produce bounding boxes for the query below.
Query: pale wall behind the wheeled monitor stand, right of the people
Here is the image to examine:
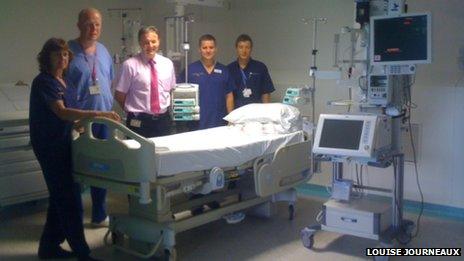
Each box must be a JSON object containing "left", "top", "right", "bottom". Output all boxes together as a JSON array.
[{"left": 232, "top": 0, "right": 464, "bottom": 208}]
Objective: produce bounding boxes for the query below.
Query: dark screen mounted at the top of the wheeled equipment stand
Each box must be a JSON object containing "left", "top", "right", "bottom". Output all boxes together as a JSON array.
[{"left": 371, "top": 14, "right": 431, "bottom": 64}]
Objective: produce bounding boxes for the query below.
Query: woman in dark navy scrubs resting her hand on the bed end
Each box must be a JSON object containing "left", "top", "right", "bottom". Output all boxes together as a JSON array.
[{"left": 29, "top": 38, "right": 120, "bottom": 260}]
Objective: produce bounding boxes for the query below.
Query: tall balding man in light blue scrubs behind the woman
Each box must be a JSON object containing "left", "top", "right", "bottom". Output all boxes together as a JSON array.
[{"left": 65, "top": 8, "right": 114, "bottom": 226}]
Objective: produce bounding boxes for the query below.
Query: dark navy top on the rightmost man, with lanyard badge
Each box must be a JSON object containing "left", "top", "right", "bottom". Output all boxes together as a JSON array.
[{"left": 227, "top": 59, "right": 275, "bottom": 108}]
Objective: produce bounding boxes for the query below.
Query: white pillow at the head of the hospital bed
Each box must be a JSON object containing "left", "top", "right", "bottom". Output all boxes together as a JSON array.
[{"left": 224, "top": 103, "right": 301, "bottom": 130}]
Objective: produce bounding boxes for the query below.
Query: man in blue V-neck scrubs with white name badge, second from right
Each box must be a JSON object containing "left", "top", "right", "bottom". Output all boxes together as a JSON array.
[{"left": 178, "top": 34, "right": 234, "bottom": 129}]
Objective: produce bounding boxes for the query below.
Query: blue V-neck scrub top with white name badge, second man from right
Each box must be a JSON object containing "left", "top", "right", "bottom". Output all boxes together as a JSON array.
[{"left": 177, "top": 61, "right": 234, "bottom": 129}]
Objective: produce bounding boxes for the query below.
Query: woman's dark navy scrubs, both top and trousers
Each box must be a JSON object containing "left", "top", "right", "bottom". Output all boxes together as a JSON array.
[{"left": 29, "top": 73, "right": 90, "bottom": 258}]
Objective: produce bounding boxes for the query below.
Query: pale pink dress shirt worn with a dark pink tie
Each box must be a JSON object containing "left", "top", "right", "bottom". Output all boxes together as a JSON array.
[{"left": 116, "top": 53, "right": 176, "bottom": 114}]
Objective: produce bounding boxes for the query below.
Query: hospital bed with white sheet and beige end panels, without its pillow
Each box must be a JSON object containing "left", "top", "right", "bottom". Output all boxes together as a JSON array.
[{"left": 72, "top": 118, "right": 312, "bottom": 258}]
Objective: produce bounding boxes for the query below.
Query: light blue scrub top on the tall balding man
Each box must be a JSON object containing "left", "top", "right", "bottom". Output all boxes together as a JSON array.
[{"left": 66, "top": 40, "right": 114, "bottom": 111}]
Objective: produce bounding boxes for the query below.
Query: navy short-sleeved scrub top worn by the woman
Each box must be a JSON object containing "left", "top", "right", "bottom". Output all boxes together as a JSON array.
[{"left": 29, "top": 73, "right": 72, "bottom": 150}]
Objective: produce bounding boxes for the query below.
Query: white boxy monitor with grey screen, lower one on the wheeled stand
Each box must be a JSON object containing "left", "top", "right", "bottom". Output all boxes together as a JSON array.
[{"left": 313, "top": 114, "right": 391, "bottom": 159}]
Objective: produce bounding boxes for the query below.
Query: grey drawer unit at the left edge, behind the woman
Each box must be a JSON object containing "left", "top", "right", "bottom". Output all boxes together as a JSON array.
[{"left": 0, "top": 83, "right": 48, "bottom": 207}]
